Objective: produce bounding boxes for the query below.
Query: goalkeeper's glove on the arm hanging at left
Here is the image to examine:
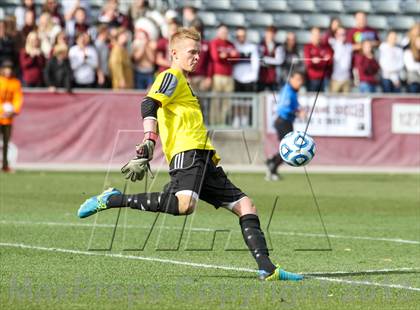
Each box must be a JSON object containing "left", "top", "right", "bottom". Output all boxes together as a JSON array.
[{"left": 121, "top": 139, "right": 155, "bottom": 182}]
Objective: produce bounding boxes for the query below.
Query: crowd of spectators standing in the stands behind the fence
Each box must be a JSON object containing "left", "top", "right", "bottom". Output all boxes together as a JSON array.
[{"left": 0, "top": 0, "right": 420, "bottom": 94}]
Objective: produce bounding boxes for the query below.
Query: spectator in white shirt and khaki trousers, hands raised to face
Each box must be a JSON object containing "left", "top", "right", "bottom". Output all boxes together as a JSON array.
[{"left": 328, "top": 27, "right": 353, "bottom": 93}]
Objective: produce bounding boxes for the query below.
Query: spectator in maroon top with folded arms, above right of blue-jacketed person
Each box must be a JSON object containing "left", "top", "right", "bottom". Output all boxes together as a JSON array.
[{"left": 303, "top": 27, "right": 334, "bottom": 91}]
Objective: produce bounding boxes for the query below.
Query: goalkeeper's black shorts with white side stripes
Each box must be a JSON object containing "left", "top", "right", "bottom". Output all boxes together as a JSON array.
[{"left": 167, "top": 150, "right": 246, "bottom": 209}]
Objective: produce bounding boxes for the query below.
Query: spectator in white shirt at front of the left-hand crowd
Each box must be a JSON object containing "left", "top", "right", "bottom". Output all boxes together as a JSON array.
[{"left": 69, "top": 32, "right": 98, "bottom": 88}]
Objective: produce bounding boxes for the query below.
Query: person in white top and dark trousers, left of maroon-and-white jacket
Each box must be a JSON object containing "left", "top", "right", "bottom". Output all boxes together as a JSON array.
[{"left": 232, "top": 27, "right": 260, "bottom": 128}]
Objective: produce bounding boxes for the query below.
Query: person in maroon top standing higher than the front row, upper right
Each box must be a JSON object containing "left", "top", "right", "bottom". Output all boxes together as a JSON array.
[{"left": 347, "top": 12, "right": 379, "bottom": 52}]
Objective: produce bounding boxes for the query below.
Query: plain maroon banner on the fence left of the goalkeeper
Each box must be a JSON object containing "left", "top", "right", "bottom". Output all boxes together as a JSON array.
[{"left": 12, "top": 92, "right": 162, "bottom": 164}]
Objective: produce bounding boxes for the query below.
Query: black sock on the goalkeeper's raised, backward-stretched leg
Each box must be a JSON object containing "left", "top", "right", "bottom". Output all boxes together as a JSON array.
[{"left": 107, "top": 192, "right": 179, "bottom": 215}]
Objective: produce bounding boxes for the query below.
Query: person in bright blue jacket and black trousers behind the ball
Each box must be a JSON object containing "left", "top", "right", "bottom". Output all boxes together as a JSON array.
[{"left": 265, "top": 71, "right": 304, "bottom": 181}]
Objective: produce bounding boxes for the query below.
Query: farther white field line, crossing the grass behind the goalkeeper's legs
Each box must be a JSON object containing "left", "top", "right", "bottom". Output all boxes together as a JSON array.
[{"left": 0, "top": 220, "right": 420, "bottom": 244}]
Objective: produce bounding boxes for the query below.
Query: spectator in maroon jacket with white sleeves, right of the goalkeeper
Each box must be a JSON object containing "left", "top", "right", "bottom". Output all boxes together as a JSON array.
[{"left": 258, "top": 26, "right": 285, "bottom": 91}]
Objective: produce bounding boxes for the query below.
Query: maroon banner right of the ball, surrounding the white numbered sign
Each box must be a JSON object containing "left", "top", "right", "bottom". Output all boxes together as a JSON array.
[{"left": 265, "top": 96, "right": 420, "bottom": 167}]
